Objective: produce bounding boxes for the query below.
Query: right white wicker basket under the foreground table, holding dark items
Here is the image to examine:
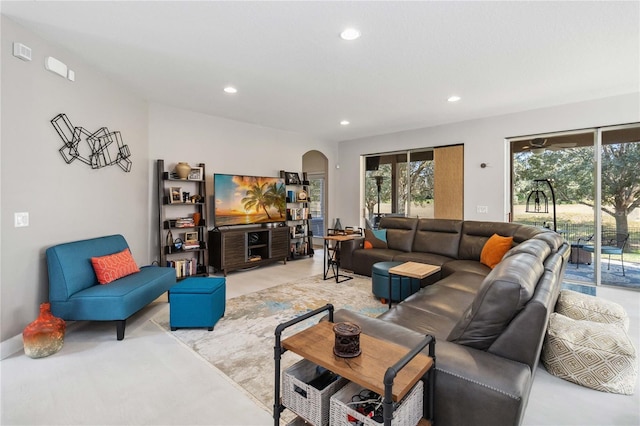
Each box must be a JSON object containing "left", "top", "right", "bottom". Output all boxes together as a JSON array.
[{"left": 330, "top": 380, "right": 423, "bottom": 426}]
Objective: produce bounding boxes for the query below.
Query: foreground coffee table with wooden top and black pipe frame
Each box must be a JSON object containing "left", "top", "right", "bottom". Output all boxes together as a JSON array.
[{"left": 274, "top": 305, "right": 435, "bottom": 425}]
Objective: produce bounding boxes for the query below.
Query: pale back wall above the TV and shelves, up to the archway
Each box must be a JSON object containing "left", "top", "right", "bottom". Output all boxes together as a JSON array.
[{"left": 149, "top": 104, "right": 337, "bottom": 256}]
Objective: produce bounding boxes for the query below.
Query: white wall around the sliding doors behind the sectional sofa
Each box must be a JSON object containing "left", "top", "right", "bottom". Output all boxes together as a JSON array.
[{"left": 335, "top": 93, "right": 640, "bottom": 225}]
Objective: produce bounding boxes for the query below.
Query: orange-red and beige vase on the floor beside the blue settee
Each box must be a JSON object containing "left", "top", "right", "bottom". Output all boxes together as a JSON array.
[{"left": 22, "top": 303, "right": 67, "bottom": 358}]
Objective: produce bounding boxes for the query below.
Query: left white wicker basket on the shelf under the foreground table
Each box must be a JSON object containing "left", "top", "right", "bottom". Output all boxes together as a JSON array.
[{"left": 282, "top": 359, "right": 349, "bottom": 426}]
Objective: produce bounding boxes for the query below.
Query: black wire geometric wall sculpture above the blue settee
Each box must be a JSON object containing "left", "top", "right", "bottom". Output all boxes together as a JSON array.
[{"left": 51, "top": 114, "right": 131, "bottom": 172}]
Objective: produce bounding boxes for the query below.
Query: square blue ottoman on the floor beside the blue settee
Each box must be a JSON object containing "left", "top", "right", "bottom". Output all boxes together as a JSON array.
[{"left": 169, "top": 277, "right": 226, "bottom": 331}]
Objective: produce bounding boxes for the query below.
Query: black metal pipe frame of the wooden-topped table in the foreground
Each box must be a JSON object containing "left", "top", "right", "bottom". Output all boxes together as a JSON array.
[{"left": 273, "top": 303, "right": 436, "bottom": 426}]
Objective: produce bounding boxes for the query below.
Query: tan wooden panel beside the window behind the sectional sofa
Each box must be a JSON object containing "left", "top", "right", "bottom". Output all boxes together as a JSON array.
[{"left": 433, "top": 145, "right": 464, "bottom": 220}]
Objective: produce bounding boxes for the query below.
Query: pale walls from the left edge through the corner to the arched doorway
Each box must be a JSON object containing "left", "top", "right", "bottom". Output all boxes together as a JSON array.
[{"left": 0, "top": 16, "right": 337, "bottom": 352}]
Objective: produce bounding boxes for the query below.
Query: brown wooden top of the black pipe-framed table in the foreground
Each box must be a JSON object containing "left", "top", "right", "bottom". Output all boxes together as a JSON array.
[{"left": 282, "top": 321, "right": 433, "bottom": 401}]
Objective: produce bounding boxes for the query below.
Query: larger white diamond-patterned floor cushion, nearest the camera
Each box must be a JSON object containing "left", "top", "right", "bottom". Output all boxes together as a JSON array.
[{"left": 542, "top": 313, "right": 638, "bottom": 395}]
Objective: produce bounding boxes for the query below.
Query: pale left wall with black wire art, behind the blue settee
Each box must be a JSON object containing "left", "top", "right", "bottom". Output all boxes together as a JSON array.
[{"left": 0, "top": 16, "right": 149, "bottom": 353}]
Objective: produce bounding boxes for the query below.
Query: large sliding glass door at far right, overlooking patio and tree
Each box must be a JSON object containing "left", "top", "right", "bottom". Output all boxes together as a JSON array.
[{"left": 510, "top": 124, "right": 640, "bottom": 288}]
